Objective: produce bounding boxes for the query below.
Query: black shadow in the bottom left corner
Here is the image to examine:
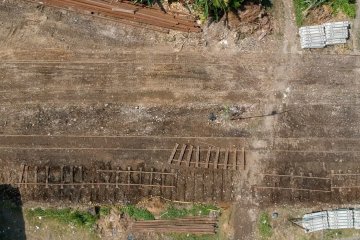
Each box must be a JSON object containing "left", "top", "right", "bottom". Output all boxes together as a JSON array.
[{"left": 0, "top": 184, "right": 26, "bottom": 240}]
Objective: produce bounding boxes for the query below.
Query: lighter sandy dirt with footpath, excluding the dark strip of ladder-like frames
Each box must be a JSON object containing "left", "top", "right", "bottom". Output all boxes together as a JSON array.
[{"left": 0, "top": 1, "right": 360, "bottom": 239}]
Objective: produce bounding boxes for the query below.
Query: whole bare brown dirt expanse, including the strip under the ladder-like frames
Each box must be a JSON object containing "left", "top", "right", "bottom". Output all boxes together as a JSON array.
[{"left": 0, "top": 1, "right": 360, "bottom": 239}]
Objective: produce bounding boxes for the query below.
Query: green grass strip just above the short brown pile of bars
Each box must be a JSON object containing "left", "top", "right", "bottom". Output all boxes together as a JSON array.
[{"left": 161, "top": 204, "right": 219, "bottom": 219}]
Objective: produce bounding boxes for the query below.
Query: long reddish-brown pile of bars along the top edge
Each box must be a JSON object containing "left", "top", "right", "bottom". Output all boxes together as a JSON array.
[{"left": 28, "top": 0, "right": 201, "bottom": 32}]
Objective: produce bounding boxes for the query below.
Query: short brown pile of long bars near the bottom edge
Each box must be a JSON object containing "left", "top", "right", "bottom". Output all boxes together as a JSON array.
[{"left": 132, "top": 217, "right": 217, "bottom": 234}]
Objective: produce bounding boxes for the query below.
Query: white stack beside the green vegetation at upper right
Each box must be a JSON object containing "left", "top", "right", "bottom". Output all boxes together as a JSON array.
[{"left": 299, "top": 21, "right": 350, "bottom": 48}]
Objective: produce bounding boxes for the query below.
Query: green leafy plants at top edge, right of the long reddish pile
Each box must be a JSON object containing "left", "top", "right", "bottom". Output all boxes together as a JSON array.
[{"left": 193, "top": 0, "right": 244, "bottom": 21}]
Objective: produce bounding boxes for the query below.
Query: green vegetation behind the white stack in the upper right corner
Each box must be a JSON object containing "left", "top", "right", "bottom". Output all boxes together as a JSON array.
[{"left": 294, "top": 0, "right": 356, "bottom": 26}]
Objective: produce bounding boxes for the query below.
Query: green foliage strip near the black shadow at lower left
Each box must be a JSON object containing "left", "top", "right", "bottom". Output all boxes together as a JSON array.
[{"left": 27, "top": 208, "right": 97, "bottom": 229}]
